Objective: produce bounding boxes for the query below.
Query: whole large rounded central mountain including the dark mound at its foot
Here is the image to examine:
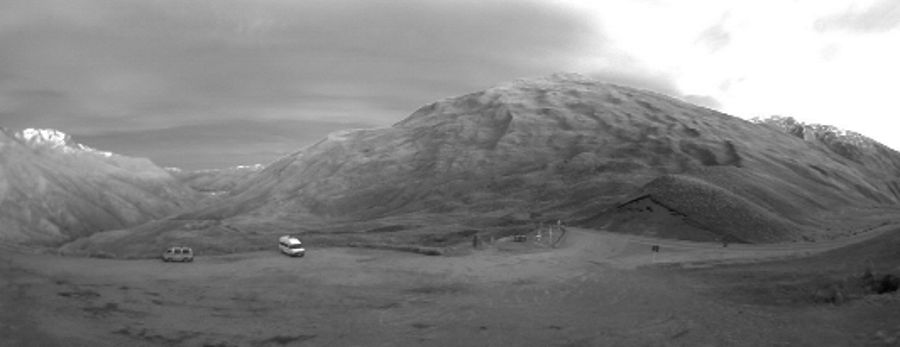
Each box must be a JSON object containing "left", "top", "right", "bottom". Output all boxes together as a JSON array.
[{"left": 59, "top": 74, "right": 900, "bottom": 256}]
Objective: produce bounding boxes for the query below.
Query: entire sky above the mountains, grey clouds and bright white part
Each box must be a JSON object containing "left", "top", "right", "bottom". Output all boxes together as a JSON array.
[{"left": 0, "top": 0, "right": 900, "bottom": 170}]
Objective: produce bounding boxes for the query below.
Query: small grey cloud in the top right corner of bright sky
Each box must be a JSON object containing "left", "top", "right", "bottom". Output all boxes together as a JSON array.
[{"left": 814, "top": 0, "right": 900, "bottom": 33}]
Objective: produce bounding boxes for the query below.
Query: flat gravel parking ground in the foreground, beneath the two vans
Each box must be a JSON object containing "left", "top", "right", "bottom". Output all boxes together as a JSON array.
[{"left": 0, "top": 229, "right": 900, "bottom": 346}]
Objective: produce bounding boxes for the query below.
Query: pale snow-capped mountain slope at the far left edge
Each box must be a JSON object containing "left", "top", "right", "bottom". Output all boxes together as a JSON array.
[{"left": 0, "top": 128, "right": 197, "bottom": 244}]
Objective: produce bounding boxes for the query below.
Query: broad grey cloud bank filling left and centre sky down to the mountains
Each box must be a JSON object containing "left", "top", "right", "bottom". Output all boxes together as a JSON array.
[{"left": 0, "top": 0, "right": 729, "bottom": 167}]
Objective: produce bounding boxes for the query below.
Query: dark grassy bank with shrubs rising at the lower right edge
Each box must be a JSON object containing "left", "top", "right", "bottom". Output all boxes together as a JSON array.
[{"left": 686, "top": 223, "right": 900, "bottom": 306}]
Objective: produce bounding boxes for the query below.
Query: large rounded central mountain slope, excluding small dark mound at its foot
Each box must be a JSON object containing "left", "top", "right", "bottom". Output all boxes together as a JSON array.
[{"left": 209, "top": 75, "right": 900, "bottom": 224}]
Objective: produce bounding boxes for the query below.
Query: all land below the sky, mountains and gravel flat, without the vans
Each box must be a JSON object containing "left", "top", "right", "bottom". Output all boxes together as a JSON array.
[{"left": 0, "top": 74, "right": 900, "bottom": 346}]
